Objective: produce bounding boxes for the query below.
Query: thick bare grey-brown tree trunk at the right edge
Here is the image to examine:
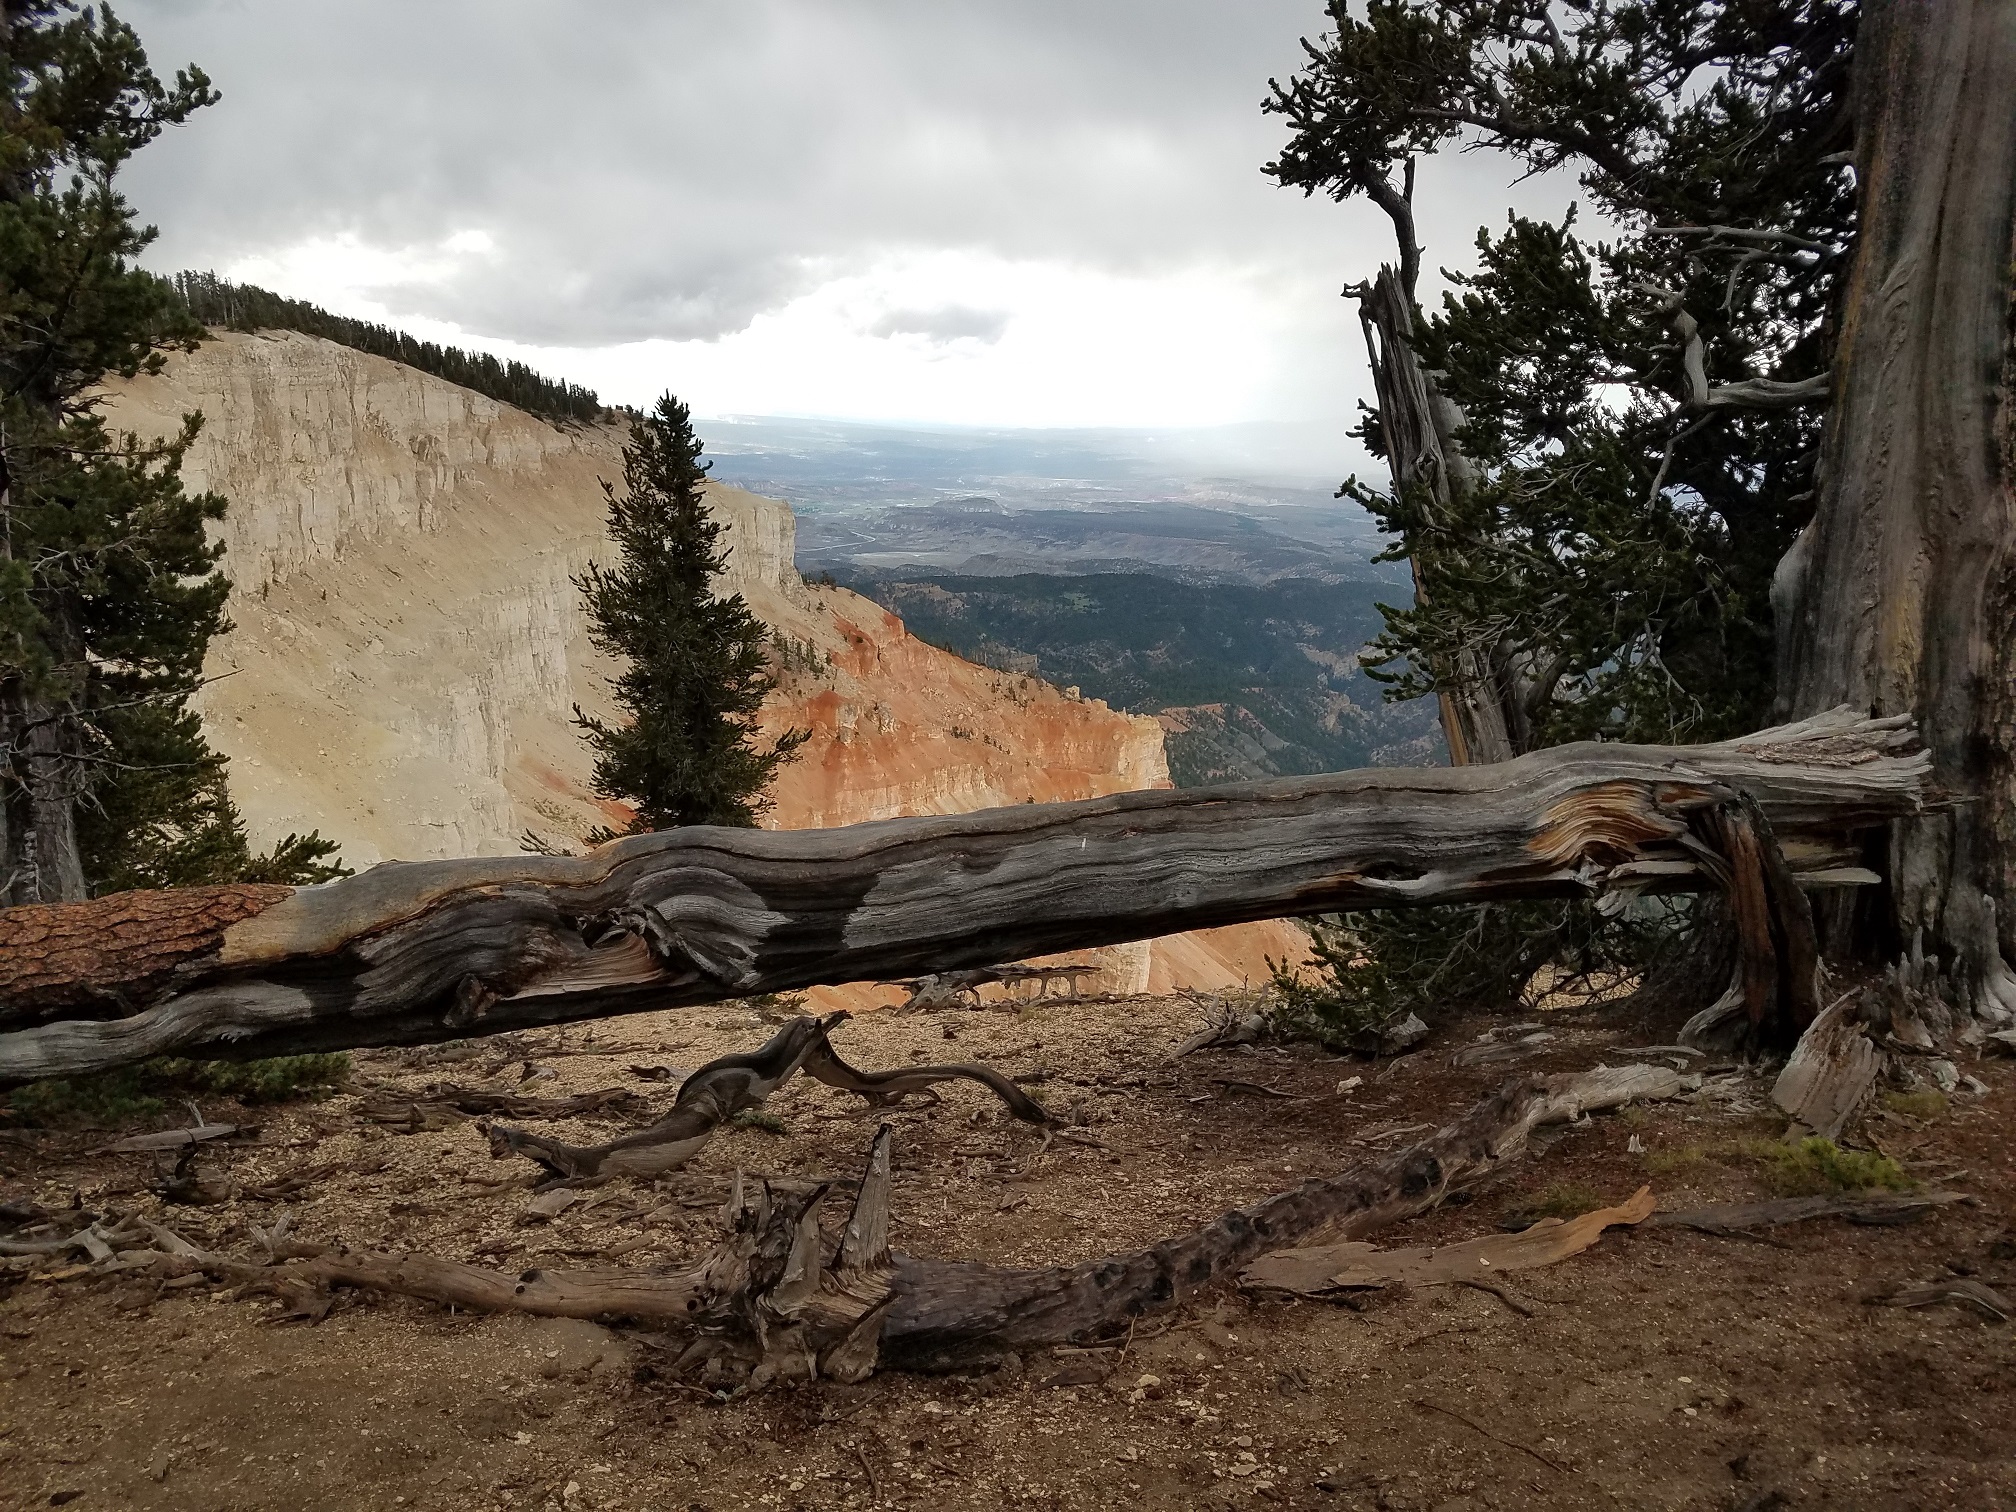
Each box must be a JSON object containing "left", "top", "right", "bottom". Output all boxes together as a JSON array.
[{"left": 1774, "top": 0, "right": 2016, "bottom": 1020}]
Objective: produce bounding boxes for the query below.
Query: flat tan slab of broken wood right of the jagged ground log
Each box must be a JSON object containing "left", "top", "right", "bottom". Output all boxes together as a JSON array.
[{"left": 1240, "top": 1187, "right": 1653, "bottom": 1296}]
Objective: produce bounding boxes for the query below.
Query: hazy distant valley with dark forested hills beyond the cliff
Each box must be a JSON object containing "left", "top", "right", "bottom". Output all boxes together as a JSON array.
[{"left": 710, "top": 421, "right": 1441, "bottom": 786}]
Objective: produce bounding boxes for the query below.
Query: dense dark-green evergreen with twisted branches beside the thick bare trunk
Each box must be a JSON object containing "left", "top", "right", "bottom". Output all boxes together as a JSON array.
[{"left": 1268, "top": 0, "right": 1859, "bottom": 754}]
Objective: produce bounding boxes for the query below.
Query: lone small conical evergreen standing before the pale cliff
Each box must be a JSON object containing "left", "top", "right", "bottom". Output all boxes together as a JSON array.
[{"left": 575, "top": 393, "right": 806, "bottom": 839}]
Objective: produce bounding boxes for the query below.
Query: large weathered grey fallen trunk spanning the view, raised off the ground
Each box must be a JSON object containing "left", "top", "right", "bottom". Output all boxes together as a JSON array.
[{"left": 0, "top": 710, "right": 1925, "bottom": 1085}]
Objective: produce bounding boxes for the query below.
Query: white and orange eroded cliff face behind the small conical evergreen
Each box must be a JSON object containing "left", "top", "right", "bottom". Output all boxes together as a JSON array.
[{"left": 105, "top": 333, "right": 1298, "bottom": 990}]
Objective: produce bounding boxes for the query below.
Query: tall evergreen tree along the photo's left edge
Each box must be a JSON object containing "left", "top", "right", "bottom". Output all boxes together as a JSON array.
[{"left": 0, "top": 0, "right": 335, "bottom": 905}]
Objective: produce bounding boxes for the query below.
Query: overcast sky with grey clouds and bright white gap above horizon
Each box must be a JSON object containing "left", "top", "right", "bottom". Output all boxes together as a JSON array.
[{"left": 119, "top": 0, "right": 1572, "bottom": 461}]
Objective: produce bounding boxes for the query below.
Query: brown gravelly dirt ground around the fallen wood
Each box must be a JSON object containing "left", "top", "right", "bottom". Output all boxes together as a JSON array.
[{"left": 0, "top": 1000, "right": 2016, "bottom": 1512}]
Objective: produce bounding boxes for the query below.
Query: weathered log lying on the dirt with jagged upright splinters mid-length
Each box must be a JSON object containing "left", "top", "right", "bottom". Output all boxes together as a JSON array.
[{"left": 138, "top": 1066, "right": 1697, "bottom": 1385}]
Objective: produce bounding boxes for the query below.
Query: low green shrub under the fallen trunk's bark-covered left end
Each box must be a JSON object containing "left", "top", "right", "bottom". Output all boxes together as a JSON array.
[{"left": 0, "top": 1052, "right": 351, "bottom": 1129}]
